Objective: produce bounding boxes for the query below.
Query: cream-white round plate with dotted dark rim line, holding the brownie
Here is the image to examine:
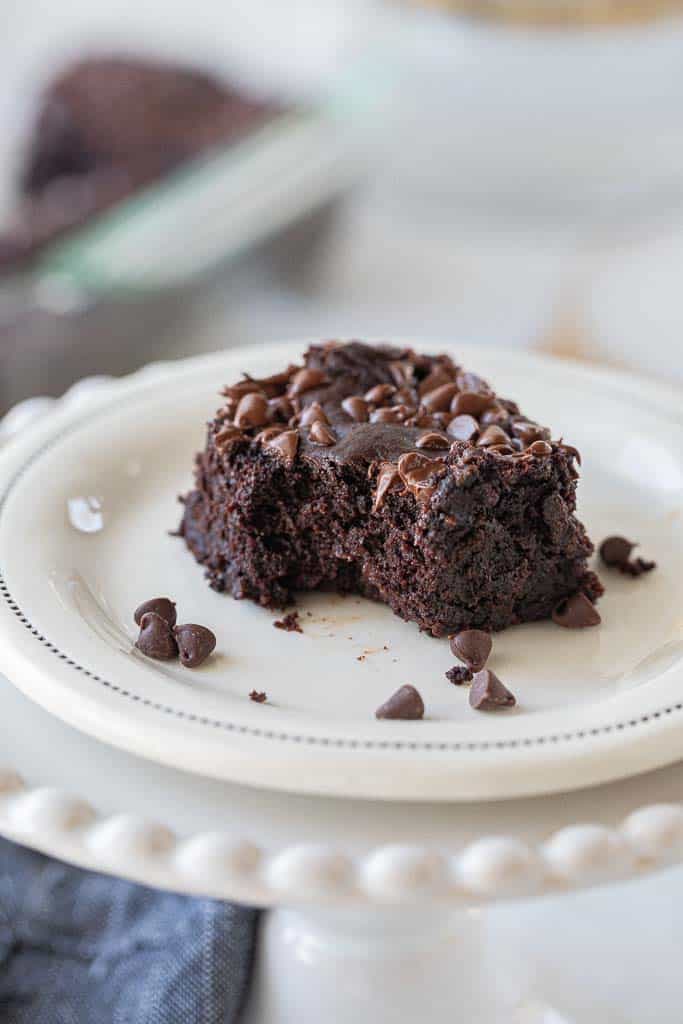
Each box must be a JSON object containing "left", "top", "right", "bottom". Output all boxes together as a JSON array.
[{"left": 0, "top": 345, "right": 683, "bottom": 800}]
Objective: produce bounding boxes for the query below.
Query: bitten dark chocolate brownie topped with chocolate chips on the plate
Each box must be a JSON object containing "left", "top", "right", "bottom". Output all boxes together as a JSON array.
[{"left": 180, "top": 341, "right": 602, "bottom": 636}]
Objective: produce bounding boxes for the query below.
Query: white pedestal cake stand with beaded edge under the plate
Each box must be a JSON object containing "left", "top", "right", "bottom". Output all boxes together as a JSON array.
[{"left": 0, "top": 381, "right": 683, "bottom": 1024}]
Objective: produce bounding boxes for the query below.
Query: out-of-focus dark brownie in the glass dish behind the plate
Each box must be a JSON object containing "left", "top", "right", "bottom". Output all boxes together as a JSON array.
[{"left": 0, "top": 56, "right": 274, "bottom": 268}]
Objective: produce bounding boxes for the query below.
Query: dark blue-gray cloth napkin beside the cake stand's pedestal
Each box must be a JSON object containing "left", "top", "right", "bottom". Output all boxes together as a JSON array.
[{"left": 0, "top": 840, "right": 258, "bottom": 1024}]
